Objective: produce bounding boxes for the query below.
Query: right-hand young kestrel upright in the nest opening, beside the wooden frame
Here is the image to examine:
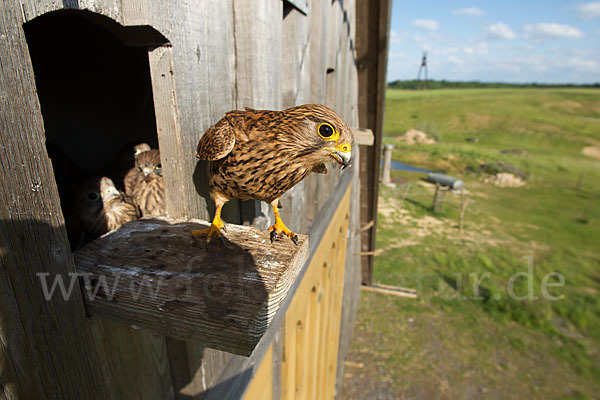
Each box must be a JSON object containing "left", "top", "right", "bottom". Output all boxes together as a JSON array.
[{"left": 125, "top": 150, "right": 166, "bottom": 217}]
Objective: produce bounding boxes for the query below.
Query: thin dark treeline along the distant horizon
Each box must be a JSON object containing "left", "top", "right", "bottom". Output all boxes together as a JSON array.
[{"left": 388, "top": 80, "right": 600, "bottom": 90}]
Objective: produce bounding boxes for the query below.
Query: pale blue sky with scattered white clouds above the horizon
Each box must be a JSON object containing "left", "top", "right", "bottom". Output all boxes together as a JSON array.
[{"left": 387, "top": 0, "right": 600, "bottom": 83}]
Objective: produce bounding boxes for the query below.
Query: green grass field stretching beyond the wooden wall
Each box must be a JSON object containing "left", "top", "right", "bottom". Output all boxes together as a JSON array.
[{"left": 344, "top": 89, "right": 600, "bottom": 399}]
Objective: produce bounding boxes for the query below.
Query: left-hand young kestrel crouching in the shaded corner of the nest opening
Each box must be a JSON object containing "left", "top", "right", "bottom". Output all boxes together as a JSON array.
[{"left": 66, "top": 177, "right": 140, "bottom": 250}]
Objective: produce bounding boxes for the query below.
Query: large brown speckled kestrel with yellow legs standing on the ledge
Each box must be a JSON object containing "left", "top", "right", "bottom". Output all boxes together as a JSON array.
[{"left": 192, "top": 104, "right": 354, "bottom": 244}]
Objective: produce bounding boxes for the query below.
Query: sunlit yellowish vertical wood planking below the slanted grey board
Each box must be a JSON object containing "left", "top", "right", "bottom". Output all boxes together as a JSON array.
[{"left": 282, "top": 188, "right": 351, "bottom": 399}]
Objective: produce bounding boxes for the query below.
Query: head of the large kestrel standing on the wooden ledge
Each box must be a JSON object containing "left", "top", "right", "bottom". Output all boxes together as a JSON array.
[{"left": 286, "top": 104, "right": 354, "bottom": 169}]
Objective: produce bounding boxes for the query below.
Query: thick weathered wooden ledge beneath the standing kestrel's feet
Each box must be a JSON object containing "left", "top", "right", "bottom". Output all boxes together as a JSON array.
[{"left": 75, "top": 218, "right": 308, "bottom": 356}]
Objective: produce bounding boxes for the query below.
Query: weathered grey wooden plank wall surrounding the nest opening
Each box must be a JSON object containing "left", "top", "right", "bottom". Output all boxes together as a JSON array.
[{"left": 0, "top": 0, "right": 360, "bottom": 399}]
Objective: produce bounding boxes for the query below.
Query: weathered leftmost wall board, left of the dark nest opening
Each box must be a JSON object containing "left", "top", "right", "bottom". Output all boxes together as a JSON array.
[{"left": 0, "top": 0, "right": 111, "bottom": 398}]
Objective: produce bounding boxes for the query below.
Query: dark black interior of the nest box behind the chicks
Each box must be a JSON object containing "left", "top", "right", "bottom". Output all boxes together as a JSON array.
[{"left": 24, "top": 10, "right": 168, "bottom": 249}]
